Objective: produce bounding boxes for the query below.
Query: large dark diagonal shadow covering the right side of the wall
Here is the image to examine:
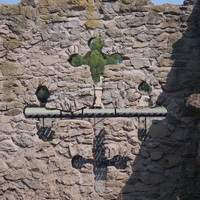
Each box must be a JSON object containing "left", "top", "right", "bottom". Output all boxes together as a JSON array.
[{"left": 118, "top": 1, "right": 200, "bottom": 200}]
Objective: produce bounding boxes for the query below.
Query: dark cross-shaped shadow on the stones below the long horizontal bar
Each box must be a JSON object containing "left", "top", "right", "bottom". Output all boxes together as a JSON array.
[{"left": 72, "top": 129, "right": 128, "bottom": 192}]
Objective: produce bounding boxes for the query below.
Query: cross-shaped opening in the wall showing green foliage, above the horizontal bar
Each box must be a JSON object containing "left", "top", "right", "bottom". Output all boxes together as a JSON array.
[{"left": 70, "top": 38, "right": 123, "bottom": 83}]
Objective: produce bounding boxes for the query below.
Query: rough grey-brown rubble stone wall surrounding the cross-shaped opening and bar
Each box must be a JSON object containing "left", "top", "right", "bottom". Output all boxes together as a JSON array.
[{"left": 0, "top": 0, "right": 200, "bottom": 200}]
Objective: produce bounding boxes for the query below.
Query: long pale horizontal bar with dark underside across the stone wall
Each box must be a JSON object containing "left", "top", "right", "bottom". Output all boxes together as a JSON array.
[{"left": 24, "top": 107, "right": 167, "bottom": 119}]
